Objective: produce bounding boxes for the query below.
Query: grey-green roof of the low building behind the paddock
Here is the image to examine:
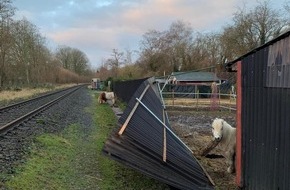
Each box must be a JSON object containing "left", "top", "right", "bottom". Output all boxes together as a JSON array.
[{"left": 171, "top": 72, "right": 221, "bottom": 82}]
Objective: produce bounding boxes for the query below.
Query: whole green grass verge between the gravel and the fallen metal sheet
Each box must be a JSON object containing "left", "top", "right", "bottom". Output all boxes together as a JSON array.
[{"left": 0, "top": 92, "right": 169, "bottom": 190}]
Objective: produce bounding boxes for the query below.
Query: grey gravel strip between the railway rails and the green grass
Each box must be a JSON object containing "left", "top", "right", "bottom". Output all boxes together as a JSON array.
[{"left": 0, "top": 87, "right": 93, "bottom": 186}]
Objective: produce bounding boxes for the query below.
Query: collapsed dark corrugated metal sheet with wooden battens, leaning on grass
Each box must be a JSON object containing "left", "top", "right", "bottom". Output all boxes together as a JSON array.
[{"left": 103, "top": 78, "right": 214, "bottom": 190}]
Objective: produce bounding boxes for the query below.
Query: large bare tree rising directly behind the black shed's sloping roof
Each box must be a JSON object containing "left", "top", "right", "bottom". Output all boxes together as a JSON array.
[{"left": 220, "top": 1, "right": 289, "bottom": 60}]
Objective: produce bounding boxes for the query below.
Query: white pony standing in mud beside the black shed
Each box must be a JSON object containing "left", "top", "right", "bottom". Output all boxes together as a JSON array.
[{"left": 212, "top": 118, "right": 236, "bottom": 173}]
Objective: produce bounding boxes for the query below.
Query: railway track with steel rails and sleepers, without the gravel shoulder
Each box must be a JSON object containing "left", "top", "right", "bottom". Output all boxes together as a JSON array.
[{"left": 0, "top": 85, "right": 82, "bottom": 133}]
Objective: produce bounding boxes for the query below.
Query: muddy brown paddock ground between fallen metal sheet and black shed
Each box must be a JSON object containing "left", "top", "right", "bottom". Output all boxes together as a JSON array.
[{"left": 167, "top": 108, "right": 238, "bottom": 190}]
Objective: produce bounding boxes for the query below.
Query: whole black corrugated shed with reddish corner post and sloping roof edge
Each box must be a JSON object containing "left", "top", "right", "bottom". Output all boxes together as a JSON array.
[{"left": 226, "top": 31, "right": 290, "bottom": 190}]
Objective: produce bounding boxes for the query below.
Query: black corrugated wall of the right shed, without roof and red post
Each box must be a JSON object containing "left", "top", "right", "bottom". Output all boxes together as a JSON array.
[{"left": 241, "top": 41, "right": 290, "bottom": 190}]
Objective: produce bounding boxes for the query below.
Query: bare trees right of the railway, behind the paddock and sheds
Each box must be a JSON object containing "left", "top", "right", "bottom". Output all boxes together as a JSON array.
[{"left": 98, "top": 1, "right": 290, "bottom": 80}]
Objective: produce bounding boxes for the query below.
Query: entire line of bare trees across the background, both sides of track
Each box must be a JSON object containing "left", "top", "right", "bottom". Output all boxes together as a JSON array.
[{"left": 0, "top": 0, "right": 290, "bottom": 89}]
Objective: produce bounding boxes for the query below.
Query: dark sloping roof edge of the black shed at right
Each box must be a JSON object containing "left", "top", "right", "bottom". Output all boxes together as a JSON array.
[{"left": 225, "top": 30, "right": 290, "bottom": 72}]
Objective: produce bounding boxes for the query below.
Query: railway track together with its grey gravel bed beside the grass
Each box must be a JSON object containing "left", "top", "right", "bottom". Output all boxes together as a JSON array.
[{"left": 0, "top": 86, "right": 92, "bottom": 180}]
